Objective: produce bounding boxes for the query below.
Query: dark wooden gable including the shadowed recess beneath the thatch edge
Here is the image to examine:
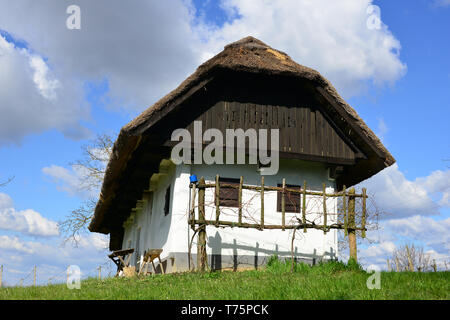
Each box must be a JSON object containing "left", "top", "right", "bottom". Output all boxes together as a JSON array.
[{"left": 166, "top": 71, "right": 364, "bottom": 165}]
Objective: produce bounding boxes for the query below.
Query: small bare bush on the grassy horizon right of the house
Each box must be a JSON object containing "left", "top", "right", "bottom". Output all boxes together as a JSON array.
[{"left": 390, "top": 244, "right": 437, "bottom": 272}]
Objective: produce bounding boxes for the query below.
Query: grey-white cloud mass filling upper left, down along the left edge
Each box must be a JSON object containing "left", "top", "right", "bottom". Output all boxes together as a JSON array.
[{"left": 0, "top": 0, "right": 198, "bottom": 145}]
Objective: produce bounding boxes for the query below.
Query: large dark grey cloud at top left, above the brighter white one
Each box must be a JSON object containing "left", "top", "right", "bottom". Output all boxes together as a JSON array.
[{"left": 0, "top": 0, "right": 199, "bottom": 110}]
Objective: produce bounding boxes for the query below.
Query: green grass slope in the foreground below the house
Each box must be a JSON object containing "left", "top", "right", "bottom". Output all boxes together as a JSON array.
[{"left": 0, "top": 259, "right": 450, "bottom": 300}]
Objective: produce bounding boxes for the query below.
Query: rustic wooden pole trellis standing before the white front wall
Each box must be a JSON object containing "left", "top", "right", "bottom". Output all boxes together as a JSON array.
[{"left": 188, "top": 175, "right": 367, "bottom": 271}]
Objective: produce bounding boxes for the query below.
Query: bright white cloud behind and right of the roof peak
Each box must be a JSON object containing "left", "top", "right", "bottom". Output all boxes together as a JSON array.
[{"left": 199, "top": 0, "right": 406, "bottom": 95}]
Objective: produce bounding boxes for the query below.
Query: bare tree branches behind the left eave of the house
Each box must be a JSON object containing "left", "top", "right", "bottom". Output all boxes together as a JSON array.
[{"left": 59, "top": 134, "right": 114, "bottom": 244}]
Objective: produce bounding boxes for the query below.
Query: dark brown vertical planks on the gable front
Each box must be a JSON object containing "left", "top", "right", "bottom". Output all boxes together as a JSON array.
[{"left": 181, "top": 101, "right": 355, "bottom": 160}]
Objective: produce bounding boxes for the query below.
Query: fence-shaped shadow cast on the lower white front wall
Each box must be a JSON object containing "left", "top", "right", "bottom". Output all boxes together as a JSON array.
[{"left": 207, "top": 232, "right": 337, "bottom": 271}]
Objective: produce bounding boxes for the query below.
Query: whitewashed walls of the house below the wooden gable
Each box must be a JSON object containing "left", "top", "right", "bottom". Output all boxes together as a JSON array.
[{"left": 123, "top": 160, "right": 337, "bottom": 271}]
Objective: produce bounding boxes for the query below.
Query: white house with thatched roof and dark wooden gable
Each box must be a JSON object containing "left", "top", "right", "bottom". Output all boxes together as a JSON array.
[{"left": 89, "top": 37, "right": 395, "bottom": 272}]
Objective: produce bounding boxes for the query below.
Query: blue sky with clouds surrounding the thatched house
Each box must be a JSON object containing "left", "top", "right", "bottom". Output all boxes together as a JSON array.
[{"left": 0, "top": 0, "right": 450, "bottom": 285}]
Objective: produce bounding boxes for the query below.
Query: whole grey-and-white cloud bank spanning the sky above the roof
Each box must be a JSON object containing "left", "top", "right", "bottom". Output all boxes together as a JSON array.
[{"left": 0, "top": 0, "right": 406, "bottom": 143}]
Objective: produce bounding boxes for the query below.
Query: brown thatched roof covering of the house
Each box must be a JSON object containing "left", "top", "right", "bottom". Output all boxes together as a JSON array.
[{"left": 89, "top": 37, "right": 395, "bottom": 233}]
